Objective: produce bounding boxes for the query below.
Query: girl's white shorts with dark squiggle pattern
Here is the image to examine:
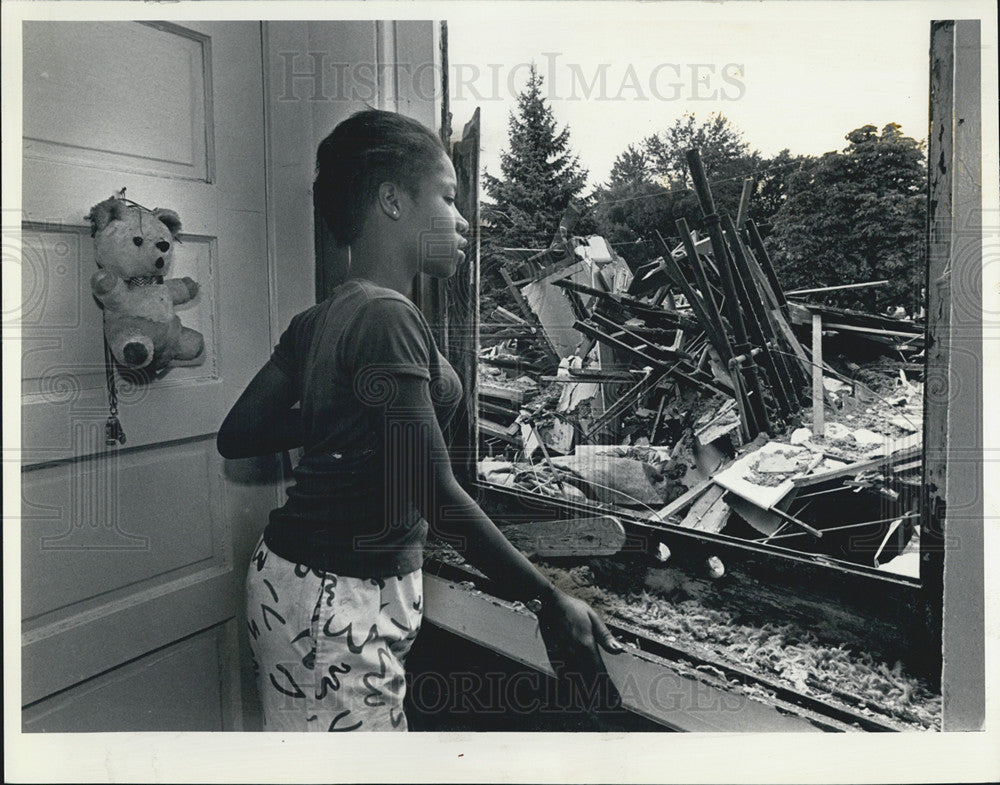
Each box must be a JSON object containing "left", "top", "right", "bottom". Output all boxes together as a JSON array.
[{"left": 246, "top": 538, "right": 423, "bottom": 731}]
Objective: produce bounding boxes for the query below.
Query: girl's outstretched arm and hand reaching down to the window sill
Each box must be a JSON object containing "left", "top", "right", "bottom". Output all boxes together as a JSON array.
[{"left": 386, "top": 376, "right": 623, "bottom": 672}]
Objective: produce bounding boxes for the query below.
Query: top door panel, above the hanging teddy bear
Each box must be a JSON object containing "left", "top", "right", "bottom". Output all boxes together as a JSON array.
[{"left": 23, "top": 22, "right": 212, "bottom": 181}]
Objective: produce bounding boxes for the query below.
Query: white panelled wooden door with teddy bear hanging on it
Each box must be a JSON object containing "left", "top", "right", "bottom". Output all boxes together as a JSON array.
[{"left": 20, "top": 22, "right": 280, "bottom": 731}]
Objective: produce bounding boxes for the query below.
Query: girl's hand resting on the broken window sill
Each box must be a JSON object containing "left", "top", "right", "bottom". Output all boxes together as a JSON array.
[{"left": 536, "top": 590, "right": 625, "bottom": 678}]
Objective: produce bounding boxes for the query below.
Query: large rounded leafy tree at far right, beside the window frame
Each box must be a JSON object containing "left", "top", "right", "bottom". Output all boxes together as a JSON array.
[{"left": 768, "top": 123, "right": 927, "bottom": 312}]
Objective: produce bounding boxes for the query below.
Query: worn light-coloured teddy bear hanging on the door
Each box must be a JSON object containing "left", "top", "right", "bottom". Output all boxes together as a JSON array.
[{"left": 87, "top": 196, "right": 205, "bottom": 373}]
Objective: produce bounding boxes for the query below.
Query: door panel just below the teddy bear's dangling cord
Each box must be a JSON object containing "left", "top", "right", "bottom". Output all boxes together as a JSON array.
[{"left": 21, "top": 444, "right": 225, "bottom": 622}]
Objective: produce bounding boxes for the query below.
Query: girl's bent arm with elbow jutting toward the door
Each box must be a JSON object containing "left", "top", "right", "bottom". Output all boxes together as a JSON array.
[{"left": 216, "top": 362, "right": 302, "bottom": 458}]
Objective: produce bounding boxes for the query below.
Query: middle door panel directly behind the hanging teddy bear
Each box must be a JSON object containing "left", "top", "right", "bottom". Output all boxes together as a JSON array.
[{"left": 21, "top": 224, "right": 221, "bottom": 463}]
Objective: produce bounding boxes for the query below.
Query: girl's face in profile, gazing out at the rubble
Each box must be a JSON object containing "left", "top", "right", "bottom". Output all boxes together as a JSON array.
[{"left": 405, "top": 152, "right": 469, "bottom": 278}]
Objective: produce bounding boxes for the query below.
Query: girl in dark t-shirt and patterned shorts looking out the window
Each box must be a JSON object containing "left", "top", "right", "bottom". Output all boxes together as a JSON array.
[{"left": 218, "top": 110, "right": 621, "bottom": 731}]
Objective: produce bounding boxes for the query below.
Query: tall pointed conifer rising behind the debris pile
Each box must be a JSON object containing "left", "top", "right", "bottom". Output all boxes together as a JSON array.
[{"left": 483, "top": 64, "right": 587, "bottom": 254}]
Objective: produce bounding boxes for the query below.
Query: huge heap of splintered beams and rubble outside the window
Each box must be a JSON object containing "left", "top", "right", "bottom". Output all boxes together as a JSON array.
[{"left": 479, "top": 150, "right": 924, "bottom": 577}]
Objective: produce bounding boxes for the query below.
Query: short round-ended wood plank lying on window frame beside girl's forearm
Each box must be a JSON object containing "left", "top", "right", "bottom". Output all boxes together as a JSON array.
[{"left": 501, "top": 515, "right": 625, "bottom": 557}]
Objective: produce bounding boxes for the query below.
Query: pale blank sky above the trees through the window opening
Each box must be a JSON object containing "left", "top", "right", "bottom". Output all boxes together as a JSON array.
[{"left": 448, "top": 3, "right": 930, "bottom": 185}]
